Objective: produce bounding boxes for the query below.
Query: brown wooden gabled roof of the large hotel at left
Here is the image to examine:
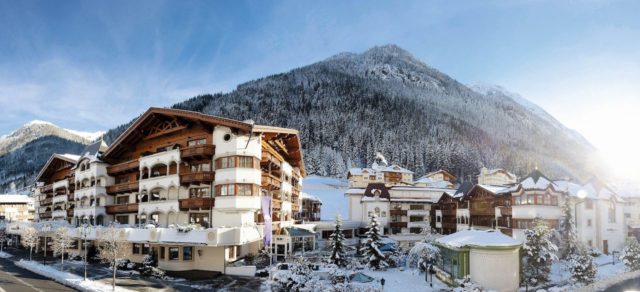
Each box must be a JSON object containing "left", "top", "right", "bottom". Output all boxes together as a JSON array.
[{"left": 103, "top": 107, "right": 252, "bottom": 158}]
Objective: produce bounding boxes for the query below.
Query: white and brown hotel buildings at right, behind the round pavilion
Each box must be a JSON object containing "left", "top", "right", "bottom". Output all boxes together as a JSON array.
[{"left": 431, "top": 170, "right": 627, "bottom": 253}]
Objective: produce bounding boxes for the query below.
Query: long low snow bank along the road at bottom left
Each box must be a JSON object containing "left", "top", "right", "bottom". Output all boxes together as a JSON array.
[{"left": 16, "top": 260, "right": 133, "bottom": 292}]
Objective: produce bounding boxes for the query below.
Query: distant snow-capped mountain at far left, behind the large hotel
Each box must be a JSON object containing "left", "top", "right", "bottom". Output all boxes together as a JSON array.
[{"left": 0, "top": 120, "right": 104, "bottom": 193}]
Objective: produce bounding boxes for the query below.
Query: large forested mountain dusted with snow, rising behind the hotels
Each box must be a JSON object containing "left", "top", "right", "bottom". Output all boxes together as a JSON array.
[{"left": 105, "top": 45, "right": 601, "bottom": 180}]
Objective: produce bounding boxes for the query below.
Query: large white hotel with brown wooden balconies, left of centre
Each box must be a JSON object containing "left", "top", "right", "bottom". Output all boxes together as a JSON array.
[{"left": 22, "top": 108, "right": 310, "bottom": 273}]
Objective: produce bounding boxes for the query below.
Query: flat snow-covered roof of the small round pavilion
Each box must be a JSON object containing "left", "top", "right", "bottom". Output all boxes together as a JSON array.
[{"left": 435, "top": 230, "right": 522, "bottom": 248}]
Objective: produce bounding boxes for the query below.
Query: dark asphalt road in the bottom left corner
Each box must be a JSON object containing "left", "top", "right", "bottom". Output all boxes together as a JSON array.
[{"left": 0, "top": 258, "right": 75, "bottom": 292}]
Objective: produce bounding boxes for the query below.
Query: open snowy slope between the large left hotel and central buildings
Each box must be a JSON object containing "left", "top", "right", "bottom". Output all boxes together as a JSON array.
[{"left": 302, "top": 175, "right": 349, "bottom": 220}]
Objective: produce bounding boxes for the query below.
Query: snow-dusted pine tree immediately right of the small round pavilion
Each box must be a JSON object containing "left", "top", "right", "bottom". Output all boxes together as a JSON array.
[{"left": 522, "top": 219, "right": 558, "bottom": 286}]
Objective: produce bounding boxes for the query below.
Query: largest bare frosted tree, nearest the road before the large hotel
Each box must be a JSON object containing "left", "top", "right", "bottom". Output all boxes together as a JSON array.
[{"left": 97, "top": 225, "right": 131, "bottom": 291}]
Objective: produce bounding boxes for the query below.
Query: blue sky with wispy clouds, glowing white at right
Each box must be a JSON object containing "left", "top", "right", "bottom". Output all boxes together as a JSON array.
[{"left": 0, "top": 0, "right": 640, "bottom": 177}]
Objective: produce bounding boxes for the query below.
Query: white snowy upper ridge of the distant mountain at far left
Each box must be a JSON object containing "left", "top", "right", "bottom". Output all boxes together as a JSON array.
[{"left": 0, "top": 120, "right": 104, "bottom": 156}]
